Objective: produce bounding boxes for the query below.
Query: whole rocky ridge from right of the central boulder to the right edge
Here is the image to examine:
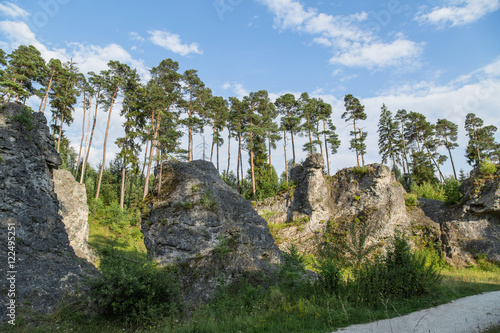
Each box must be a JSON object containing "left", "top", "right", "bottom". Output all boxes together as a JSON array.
[{"left": 256, "top": 154, "right": 500, "bottom": 266}]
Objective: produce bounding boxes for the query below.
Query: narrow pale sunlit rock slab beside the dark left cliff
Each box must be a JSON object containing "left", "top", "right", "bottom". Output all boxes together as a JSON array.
[{"left": 53, "top": 169, "right": 96, "bottom": 262}]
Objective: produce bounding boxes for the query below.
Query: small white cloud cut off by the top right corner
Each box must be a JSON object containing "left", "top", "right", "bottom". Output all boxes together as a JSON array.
[{"left": 416, "top": 0, "right": 500, "bottom": 28}]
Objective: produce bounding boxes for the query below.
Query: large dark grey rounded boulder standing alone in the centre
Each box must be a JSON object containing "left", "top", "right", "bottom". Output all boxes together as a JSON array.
[{"left": 141, "top": 161, "right": 282, "bottom": 304}]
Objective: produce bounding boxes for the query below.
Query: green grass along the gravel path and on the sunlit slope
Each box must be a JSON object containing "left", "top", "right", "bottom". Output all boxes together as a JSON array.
[{"left": 0, "top": 205, "right": 500, "bottom": 333}]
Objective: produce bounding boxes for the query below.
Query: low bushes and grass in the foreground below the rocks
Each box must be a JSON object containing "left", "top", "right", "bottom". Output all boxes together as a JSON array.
[{"left": 6, "top": 226, "right": 500, "bottom": 332}]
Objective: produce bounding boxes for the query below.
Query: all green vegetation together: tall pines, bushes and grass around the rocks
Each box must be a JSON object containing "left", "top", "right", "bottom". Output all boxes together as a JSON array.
[{"left": 0, "top": 46, "right": 500, "bottom": 332}]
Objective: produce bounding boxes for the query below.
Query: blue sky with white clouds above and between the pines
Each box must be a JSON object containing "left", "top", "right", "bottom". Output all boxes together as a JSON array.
[{"left": 0, "top": 0, "right": 500, "bottom": 174}]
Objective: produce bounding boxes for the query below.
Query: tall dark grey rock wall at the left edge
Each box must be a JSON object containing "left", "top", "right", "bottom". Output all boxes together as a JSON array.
[{"left": 0, "top": 103, "right": 96, "bottom": 321}]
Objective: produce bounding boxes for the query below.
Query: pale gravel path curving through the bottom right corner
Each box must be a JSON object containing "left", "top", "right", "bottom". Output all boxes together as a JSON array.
[{"left": 336, "top": 291, "right": 500, "bottom": 333}]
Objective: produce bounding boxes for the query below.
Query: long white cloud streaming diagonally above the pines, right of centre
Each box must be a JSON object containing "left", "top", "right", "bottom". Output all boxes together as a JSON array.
[{"left": 258, "top": 0, "right": 423, "bottom": 69}]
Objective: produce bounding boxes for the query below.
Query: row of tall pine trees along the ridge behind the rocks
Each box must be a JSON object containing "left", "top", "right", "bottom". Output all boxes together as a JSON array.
[{"left": 0, "top": 45, "right": 500, "bottom": 202}]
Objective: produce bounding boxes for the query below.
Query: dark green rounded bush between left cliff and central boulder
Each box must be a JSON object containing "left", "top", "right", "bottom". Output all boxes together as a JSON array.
[{"left": 91, "top": 253, "right": 182, "bottom": 326}]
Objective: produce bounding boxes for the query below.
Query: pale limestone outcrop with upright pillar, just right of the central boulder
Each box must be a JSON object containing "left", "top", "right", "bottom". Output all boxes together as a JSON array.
[{"left": 257, "top": 154, "right": 416, "bottom": 253}]
